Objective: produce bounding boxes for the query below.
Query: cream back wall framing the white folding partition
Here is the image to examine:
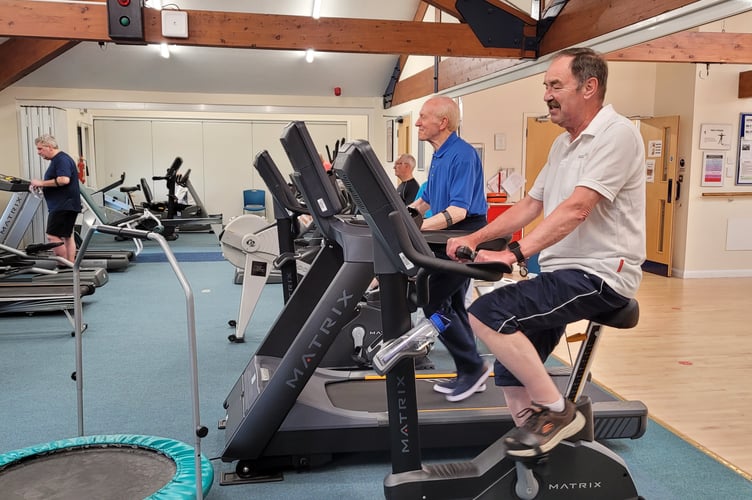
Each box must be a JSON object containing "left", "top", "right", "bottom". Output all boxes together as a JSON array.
[{"left": 0, "top": 85, "right": 378, "bottom": 217}]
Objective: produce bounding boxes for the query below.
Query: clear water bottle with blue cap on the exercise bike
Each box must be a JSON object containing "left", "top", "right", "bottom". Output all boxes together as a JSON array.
[{"left": 373, "top": 313, "right": 449, "bottom": 375}]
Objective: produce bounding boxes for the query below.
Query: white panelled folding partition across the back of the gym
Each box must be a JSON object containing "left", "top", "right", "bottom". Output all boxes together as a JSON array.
[{"left": 94, "top": 116, "right": 350, "bottom": 223}]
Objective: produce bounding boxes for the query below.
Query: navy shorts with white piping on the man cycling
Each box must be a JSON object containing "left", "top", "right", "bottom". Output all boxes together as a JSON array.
[{"left": 468, "top": 269, "right": 629, "bottom": 386}]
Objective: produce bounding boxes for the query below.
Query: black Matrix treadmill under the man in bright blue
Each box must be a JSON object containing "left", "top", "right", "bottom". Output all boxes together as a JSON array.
[{"left": 220, "top": 122, "right": 647, "bottom": 484}]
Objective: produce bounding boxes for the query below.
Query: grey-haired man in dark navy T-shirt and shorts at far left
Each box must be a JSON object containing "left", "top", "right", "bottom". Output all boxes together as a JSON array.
[{"left": 29, "top": 134, "right": 81, "bottom": 262}]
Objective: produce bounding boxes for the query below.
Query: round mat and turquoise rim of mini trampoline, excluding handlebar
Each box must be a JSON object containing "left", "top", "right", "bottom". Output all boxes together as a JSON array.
[{"left": 0, "top": 434, "right": 214, "bottom": 500}]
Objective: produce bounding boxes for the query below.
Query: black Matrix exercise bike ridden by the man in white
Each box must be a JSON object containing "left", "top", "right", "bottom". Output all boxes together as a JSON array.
[{"left": 334, "top": 141, "right": 640, "bottom": 500}]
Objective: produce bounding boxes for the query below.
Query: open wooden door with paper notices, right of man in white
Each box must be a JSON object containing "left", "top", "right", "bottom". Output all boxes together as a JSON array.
[{"left": 639, "top": 116, "right": 679, "bottom": 276}]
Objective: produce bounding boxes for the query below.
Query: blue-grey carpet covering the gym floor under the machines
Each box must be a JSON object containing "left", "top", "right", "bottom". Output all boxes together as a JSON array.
[{"left": 0, "top": 235, "right": 752, "bottom": 500}]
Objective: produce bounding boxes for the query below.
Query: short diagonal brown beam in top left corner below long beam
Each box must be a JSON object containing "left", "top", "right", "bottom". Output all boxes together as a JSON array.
[{"left": 0, "top": 38, "right": 78, "bottom": 90}]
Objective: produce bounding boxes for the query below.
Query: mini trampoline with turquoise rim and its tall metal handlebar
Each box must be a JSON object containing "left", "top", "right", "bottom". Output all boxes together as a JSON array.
[{"left": 0, "top": 225, "right": 214, "bottom": 500}]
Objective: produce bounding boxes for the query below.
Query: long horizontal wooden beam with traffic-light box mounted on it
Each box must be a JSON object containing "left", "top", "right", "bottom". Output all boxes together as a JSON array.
[{"left": 0, "top": 0, "right": 535, "bottom": 59}]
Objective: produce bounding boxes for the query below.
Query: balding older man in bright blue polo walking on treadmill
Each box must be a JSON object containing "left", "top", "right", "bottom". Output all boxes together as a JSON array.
[{"left": 409, "top": 96, "right": 492, "bottom": 401}]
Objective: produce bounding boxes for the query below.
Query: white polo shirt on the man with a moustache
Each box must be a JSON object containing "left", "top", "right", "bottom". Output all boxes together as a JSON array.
[{"left": 529, "top": 105, "right": 645, "bottom": 297}]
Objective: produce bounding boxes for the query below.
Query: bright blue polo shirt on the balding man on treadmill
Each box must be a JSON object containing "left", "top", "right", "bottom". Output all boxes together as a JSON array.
[{"left": 421, "top": 132, "right": 488, "bottom": 217}]
